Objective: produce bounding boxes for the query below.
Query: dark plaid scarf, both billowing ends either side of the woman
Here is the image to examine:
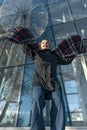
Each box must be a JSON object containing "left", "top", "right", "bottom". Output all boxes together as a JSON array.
[{"left": 0, "top": 27, "right": 87, "bottom": 58}]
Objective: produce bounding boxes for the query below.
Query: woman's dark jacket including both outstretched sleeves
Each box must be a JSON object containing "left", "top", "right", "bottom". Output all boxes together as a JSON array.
[{"left": 23, "top": 45, "right": 74, "bottom": 99}]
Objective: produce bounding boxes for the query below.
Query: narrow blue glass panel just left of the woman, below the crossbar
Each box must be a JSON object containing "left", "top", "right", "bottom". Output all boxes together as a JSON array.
[{"left": 17, "top": 63, "right": 34, "bottom": 126}]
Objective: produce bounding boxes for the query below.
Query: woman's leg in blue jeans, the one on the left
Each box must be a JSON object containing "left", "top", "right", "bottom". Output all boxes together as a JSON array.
[{"left": 31, "top": 86, "right": 45, "bottom": 130}]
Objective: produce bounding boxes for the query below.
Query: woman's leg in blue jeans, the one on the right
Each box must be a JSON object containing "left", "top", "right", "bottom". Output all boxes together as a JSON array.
[{"left": 50, "top": 90, "right": 65, "bottom": 130}]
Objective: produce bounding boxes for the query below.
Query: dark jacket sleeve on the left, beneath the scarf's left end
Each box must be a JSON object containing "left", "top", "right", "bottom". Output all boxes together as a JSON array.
[{"left": 22, "top": 45, "right": 36, "bottom": 60}]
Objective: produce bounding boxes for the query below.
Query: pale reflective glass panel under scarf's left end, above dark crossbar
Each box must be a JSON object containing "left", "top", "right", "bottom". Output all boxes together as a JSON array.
[{"left": 0, "top": 42, "right": 25, "bottom": 68}]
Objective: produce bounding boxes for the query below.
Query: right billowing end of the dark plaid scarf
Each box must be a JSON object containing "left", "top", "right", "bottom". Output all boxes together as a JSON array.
[{"left": 55, "top": 35, "right": 87, "bottom": 58}]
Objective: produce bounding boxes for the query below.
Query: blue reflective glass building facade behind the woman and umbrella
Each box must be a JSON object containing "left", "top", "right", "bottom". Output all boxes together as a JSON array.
[{"left": 0, "top": 0, "right": 87, "bottom": 127}]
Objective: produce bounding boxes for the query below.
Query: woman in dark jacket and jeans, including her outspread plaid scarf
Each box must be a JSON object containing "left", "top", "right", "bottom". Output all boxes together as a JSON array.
[{"left": 0, "top": 27, "right": 87, "bottom": 130}]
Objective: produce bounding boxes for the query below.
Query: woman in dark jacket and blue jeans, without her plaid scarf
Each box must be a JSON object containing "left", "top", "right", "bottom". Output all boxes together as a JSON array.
[{"left": 23, "top": 40, "right": 74, "bottom": 130}]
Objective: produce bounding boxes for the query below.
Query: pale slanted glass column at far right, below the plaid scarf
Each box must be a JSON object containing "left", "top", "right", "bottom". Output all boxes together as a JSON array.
[{"left": 73, "top": 57, "right": 87, "bottom": 125}]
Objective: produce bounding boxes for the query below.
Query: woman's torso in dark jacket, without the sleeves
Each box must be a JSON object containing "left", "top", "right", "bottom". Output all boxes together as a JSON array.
[{"left": 33, "top": 50, "right": 60, "bottom": 91}]
